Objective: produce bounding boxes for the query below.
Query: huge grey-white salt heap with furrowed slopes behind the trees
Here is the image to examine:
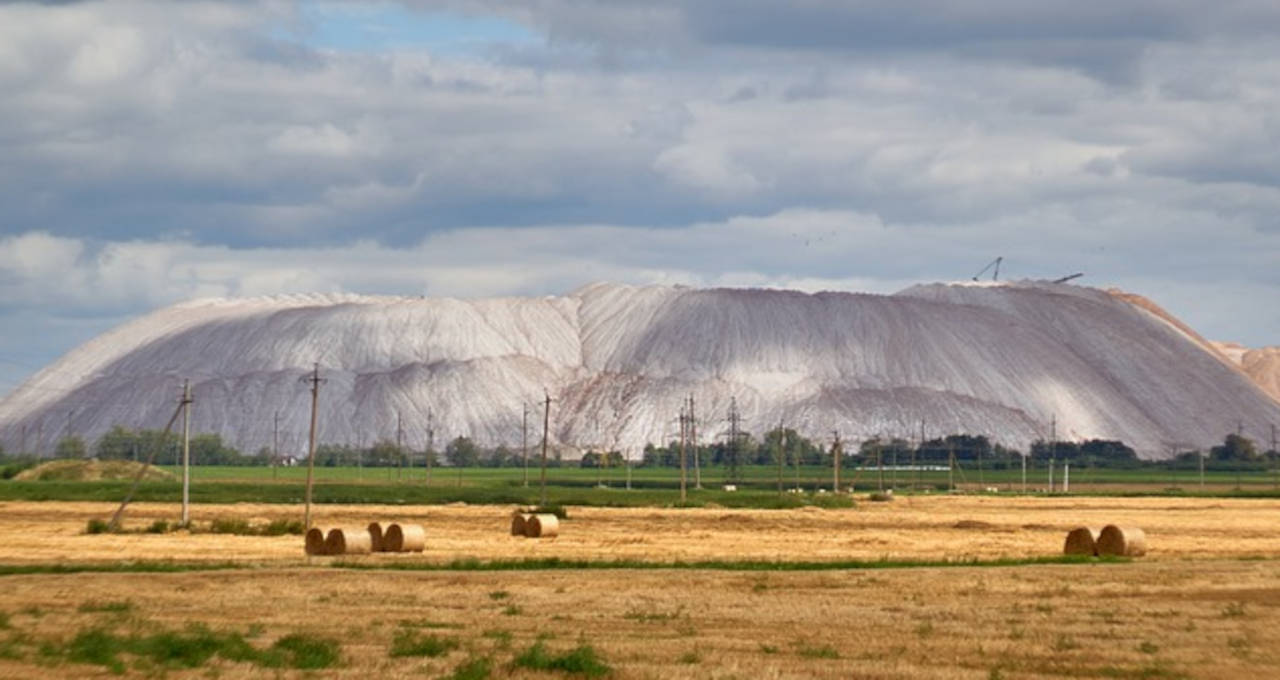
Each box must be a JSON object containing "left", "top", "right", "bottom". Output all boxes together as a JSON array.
[{"left": 0, "top": 282, "right": 1280, "bottom": 457}]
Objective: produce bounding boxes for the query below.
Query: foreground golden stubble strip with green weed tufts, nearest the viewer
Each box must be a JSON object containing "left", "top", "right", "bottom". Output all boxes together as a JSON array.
[{"left": 0, "top": 560, "right": 1280, "bottom": 679}]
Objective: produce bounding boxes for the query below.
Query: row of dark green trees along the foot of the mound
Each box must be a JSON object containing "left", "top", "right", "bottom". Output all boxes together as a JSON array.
[{"left": 0, "top": 425, "right": 1280, "bottom": 478}]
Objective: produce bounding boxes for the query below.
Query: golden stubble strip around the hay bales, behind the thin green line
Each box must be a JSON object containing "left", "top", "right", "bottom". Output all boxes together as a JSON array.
[{"left": 0, "top": 497, "right": 1280, "bottom": 566}]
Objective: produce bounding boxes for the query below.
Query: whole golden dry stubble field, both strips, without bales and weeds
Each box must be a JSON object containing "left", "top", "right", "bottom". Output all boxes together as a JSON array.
[{"left": 0, "top": 497, "right": 1280, "bottom": 677}]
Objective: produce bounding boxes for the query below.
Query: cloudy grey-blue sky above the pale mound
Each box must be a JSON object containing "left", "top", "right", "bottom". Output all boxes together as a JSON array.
[{"left": 0, "top": 0, "right": 1280, "bottom": 393}]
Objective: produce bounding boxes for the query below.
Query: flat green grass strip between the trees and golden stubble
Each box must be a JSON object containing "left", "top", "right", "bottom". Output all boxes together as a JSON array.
[{"left": 0, "top": 466, "right": 1280, "bottom": 507}]
